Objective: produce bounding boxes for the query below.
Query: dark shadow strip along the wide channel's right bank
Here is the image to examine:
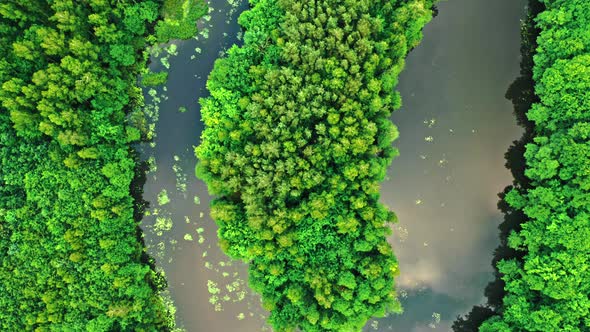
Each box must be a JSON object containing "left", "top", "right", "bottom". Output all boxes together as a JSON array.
[{"left": 452, "top": 0, "right": 544, "bottom": 332}]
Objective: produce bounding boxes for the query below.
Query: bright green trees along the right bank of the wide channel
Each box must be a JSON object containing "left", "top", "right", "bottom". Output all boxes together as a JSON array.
[{"left": 480, "top": 0, "right": 590, "bottom": 332}]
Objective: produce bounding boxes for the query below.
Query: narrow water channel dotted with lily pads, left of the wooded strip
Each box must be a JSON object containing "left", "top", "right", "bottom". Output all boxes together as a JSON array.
[{"left": 142, "top": 0, "right": 264, "bottom": 332}]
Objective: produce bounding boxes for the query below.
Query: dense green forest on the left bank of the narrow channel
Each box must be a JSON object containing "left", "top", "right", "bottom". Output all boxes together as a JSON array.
[{"left": 0, "top": 0, "right": 190, "bottom": 331}]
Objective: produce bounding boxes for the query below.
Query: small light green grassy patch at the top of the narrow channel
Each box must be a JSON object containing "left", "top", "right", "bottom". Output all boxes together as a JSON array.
[{"left": 156, "top": 0, "right": 208, "bottom": 43}]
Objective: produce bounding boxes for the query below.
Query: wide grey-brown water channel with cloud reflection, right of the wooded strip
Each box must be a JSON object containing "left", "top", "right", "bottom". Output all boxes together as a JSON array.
[{"left": 378, "top": 0, "right": 526, "bottom": 332}]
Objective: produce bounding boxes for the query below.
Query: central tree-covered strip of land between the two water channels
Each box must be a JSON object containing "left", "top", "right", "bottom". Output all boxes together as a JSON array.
[{"left": 196, "top": 0, "right": 432, "bottom": 331}]
